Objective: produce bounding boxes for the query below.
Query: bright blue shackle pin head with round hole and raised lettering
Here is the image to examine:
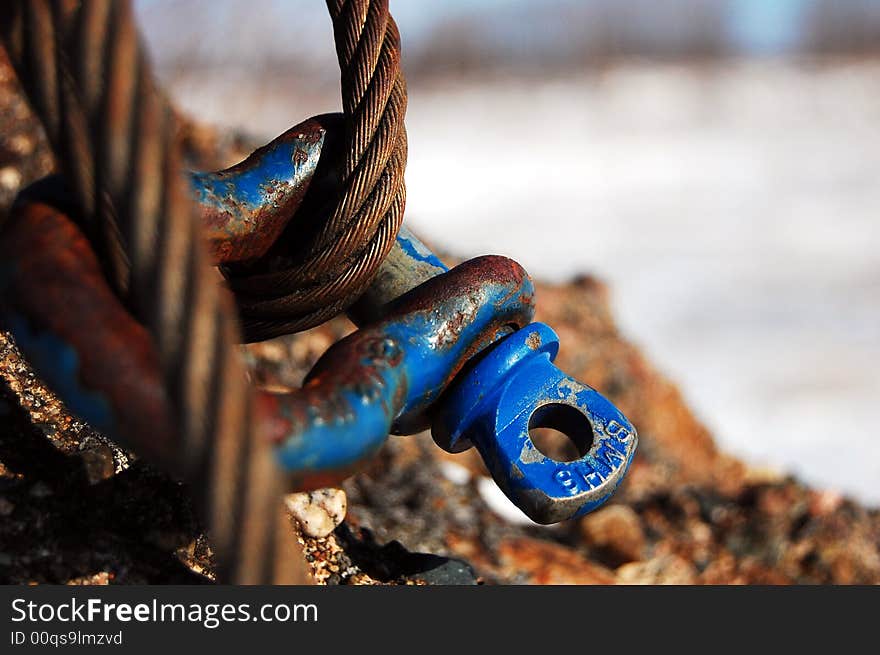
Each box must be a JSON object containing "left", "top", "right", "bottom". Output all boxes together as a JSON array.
[{"left": 432, "top": 323, "right": 638, "bottom": 523}]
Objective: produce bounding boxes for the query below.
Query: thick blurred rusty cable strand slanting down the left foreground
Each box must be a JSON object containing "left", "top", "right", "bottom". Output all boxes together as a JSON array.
[{"left": 0, "top": 0, "right": 300, "bottom": 583}]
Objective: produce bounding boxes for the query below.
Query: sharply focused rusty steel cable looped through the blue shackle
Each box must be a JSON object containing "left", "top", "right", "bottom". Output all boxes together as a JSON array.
[{"left": 224, "top": 0, "right": 407, "bottom": 341}]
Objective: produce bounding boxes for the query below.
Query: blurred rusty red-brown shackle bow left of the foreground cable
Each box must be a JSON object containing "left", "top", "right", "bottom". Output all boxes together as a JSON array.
[{"left": 0, "top": 197, "right": 179, "bottom": 462}]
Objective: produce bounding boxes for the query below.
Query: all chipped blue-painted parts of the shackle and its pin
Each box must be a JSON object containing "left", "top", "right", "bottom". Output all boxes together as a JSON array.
[{"left": 0, "top": 115, "right": 638, "bottom": 523}]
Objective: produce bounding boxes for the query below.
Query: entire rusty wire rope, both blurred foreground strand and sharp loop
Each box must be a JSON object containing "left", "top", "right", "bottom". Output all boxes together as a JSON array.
[{"left": 0, "top": 0, "right": 406, "bottom": 582}]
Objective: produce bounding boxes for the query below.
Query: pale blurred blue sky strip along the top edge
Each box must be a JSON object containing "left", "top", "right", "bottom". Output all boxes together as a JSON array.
[{"left": 134, "top": 0, "right": 880, "bottom": 67}]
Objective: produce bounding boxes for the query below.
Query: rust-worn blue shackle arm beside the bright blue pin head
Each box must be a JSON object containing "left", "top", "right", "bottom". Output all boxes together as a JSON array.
[{"left": 276, "top": 258, "right": 534, "bottom": 482}]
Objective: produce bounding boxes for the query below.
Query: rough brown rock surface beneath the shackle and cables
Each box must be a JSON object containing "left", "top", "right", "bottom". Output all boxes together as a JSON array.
[{"left": 0, "top": 48, "right": 880, "bottom": 584}]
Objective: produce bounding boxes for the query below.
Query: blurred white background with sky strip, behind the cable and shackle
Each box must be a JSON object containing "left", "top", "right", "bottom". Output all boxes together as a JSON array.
[{"left": 136, "top": 0, "right": 880, "bottom": 503}]
